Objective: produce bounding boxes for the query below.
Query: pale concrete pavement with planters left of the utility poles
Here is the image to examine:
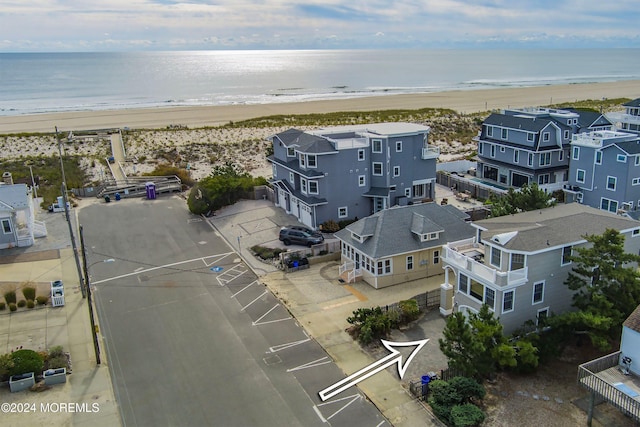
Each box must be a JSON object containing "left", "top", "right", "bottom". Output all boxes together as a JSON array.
[{"left": 0, "top": 206, "right": 121, "bottom": 426}]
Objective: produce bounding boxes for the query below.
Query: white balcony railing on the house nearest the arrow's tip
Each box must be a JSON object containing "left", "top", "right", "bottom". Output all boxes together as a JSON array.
[{"left": 444, "top": 246, "right": 529, "bottom": 286}]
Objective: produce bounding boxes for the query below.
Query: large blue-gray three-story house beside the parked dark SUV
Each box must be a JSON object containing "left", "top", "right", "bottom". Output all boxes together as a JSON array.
[{"left": 268, "top": 123, "right": 440, "bottom": 228}]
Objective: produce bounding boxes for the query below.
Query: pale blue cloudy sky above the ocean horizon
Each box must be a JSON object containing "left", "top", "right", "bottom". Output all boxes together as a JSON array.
[{"left": 0, "top": 0, "right": 640, "bottom": 52}]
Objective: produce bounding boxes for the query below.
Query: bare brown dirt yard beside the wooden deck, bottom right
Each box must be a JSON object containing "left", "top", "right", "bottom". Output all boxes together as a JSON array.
[{"left": 484, "top": 347, "right": 634, "bottom": 427}]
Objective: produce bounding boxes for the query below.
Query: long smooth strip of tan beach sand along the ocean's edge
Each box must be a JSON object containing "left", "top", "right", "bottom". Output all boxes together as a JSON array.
[{"left": 0, "top": 80, "right": 640, "bottom": 134}]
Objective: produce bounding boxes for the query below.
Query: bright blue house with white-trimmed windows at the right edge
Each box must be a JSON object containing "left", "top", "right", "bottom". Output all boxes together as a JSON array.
[{"left": 563, "top": 131, "right": 640, "bottom": 212}]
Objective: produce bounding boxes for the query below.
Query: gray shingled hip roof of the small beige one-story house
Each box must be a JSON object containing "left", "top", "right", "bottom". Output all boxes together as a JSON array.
[{"left": 335, "top": 203, "right": 475, "bottom": 259}]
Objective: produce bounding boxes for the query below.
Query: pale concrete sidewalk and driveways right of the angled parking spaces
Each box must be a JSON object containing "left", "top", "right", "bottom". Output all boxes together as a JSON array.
[{"left": 209, "top": 200, "right": 446, "bottom": 427}]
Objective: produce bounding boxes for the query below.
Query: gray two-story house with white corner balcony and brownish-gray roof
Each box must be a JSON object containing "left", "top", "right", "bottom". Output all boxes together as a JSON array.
[{"left": 440, "top": 203, "right": 640, "bottom": 334}]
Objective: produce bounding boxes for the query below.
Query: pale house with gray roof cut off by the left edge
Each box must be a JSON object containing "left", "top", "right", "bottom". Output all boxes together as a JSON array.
[{"left": 0, "top": 184, "right": 47, "bottom": 249}]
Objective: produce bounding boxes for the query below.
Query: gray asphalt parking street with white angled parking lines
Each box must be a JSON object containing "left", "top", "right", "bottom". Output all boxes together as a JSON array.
[{"left": 79, "top": 196, "right": 388, "bottom": 427}]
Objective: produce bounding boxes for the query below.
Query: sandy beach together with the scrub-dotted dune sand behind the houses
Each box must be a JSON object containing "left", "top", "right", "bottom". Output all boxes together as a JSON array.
[{"left": 0, "top": 81, "right": 640, "bottom": 182}]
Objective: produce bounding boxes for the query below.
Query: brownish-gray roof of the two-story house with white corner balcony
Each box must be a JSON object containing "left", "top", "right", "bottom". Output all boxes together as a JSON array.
[{"left": 474, "top": 203, "right": 640, "bottom": 252}]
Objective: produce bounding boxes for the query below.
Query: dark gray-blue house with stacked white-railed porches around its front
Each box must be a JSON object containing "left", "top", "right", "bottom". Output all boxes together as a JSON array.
[{"left": 477, "top": 108, "right": 611, "bottom": 192}]
